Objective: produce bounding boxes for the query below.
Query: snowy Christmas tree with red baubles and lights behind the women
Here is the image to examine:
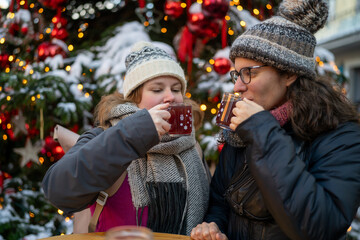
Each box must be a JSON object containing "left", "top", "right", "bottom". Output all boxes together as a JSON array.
[{"left": 0, "top": 0, "right": 360, "bottom": 240}]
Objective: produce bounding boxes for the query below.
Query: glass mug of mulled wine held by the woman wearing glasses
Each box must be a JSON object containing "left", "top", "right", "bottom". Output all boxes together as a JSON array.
[{"left": 216, "top": 92, "right": 241, "bottom": 130}]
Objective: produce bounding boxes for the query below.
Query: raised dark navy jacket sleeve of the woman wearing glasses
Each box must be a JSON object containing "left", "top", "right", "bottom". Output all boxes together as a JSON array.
[{"left": 236, "top": 111, "right": 360, "bottom": 239}]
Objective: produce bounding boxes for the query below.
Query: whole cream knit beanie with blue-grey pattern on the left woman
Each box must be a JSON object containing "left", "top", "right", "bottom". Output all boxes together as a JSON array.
[{"left": 123, "top": 41, "right": 186, "bottom": 99}]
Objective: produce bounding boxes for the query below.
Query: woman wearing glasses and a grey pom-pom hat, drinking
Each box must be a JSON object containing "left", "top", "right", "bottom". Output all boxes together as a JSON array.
[{"left": 191, "top": 0, "right": 360, "bottom": 240}]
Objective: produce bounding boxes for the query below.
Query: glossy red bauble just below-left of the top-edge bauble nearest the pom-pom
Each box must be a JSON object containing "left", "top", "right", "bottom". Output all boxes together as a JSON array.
[{"left": 187, "top": 12, "right": 219, "bottom": 38}]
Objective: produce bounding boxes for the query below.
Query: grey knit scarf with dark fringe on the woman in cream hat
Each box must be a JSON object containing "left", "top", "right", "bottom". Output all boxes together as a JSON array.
[{"left": 109, "top": 103, "right": 209, "bottom": 235}]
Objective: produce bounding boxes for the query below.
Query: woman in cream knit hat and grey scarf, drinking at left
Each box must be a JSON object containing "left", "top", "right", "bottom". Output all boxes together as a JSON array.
[{"left": 43, "top": 42, "right": 209, "bottom": 234}]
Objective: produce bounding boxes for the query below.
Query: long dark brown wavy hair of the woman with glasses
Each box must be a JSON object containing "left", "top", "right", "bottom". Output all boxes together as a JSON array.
[{"left": 287, "top": 77, "right": 359, "bottom": 141}]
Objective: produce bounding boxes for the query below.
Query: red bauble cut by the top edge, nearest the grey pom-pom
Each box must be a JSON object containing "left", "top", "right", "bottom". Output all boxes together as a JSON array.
[{"left": 201, "top": 0, "right": 229, "bottom": 19}]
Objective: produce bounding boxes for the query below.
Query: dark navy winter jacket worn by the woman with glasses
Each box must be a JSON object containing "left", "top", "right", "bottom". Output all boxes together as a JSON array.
[{"left": 205, "top": 111, "right": 360, "bottom": 240}]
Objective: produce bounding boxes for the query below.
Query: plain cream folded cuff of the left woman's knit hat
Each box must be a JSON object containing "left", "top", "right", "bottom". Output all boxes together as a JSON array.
[{"left": 123, "top": 59, "right": 186, "bottom": 98}]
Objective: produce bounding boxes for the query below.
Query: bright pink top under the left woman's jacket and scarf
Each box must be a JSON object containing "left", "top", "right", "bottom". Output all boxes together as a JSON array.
[{"left": 90, "top": 175, "right": 148, "bottom": 232}]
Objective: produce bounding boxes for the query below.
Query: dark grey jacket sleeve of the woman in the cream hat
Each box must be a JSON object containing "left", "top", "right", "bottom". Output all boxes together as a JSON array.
[{"left": 42, "top": 110, "right": 159, "bottom": 214}]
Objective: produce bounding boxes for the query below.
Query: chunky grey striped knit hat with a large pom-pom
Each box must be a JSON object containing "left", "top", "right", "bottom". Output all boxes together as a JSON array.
[{"left": 230, "top": 0, "right": 328, "bottom": 79}]
